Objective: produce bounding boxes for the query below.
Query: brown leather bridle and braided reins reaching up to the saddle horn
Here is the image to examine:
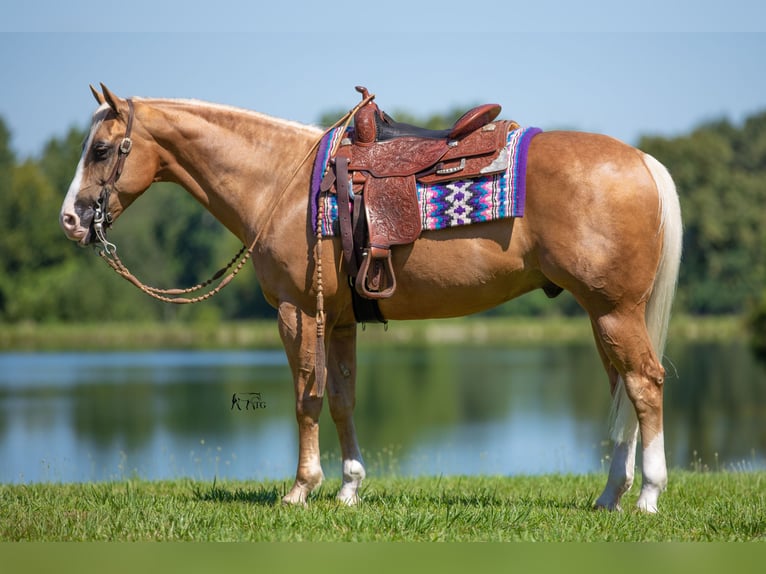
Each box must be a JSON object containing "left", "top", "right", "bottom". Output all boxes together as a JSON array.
[{"left": 93, "top": 95, "right": 375, "bottom": 308}]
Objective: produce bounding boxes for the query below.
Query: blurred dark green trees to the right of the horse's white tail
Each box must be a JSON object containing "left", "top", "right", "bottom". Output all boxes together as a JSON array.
[{"left": 640, "top": 114, "right": 766, "bottom": 314}]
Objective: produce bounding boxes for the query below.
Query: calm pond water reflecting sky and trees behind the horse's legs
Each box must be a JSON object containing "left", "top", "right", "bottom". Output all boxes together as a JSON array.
[{"left": 0, "top": 343, "right": 766, "bottom": 483}]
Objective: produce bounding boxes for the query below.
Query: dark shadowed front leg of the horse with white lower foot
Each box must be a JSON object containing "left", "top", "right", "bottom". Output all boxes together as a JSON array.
[{"left": 327, "top": 323, "right": 365, "bottom": 505}]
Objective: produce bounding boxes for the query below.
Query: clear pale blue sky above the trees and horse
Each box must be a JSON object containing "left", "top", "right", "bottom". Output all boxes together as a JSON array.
[{"left": 0, "top": 0, "right": 766, "bottom": 157}]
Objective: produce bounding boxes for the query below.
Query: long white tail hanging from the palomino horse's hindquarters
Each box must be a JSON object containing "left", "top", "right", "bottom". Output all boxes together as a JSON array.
[{"left": 611, "top": 154, "right": 683, "bottom": 443}]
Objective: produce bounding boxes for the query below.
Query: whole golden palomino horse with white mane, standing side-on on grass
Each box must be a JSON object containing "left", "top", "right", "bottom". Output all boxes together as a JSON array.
[{"left": 60, "top": 85, "right": 681, "bottom": 512}]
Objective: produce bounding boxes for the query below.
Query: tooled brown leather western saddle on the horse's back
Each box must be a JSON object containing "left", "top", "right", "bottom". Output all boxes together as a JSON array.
[{"left": 320, "top": 86, "right": 518, "bottom": 300}]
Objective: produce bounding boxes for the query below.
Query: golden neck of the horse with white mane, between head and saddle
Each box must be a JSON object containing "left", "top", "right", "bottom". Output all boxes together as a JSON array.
[{"left": 146, "top": 100, "right": 321, "bottom": 243}]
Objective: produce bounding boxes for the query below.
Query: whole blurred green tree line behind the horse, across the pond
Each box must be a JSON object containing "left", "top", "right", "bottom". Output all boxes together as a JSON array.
[{"left": 0, "top": 109, "right": 766, "bottom": 332}]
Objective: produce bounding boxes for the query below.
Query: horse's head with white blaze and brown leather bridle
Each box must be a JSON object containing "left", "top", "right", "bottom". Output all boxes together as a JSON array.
[{"left": 59, "top": 84, "right": 159, "bottom": 245}]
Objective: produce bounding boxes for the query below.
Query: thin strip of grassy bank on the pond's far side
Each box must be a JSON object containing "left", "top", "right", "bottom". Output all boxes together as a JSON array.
[{"left": 0, "top": 316, "right": 749, "bottom": 352}]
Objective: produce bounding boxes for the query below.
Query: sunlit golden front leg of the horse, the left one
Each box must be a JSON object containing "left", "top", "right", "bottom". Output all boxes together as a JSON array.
[{"left": 278, "top": 302, "right": 324, "bottom": 504}]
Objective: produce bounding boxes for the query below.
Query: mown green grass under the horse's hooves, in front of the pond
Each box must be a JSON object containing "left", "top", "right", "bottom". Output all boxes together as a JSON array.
[{"left": 0, "top": 471, "right": 766, "bottom": 542}]
